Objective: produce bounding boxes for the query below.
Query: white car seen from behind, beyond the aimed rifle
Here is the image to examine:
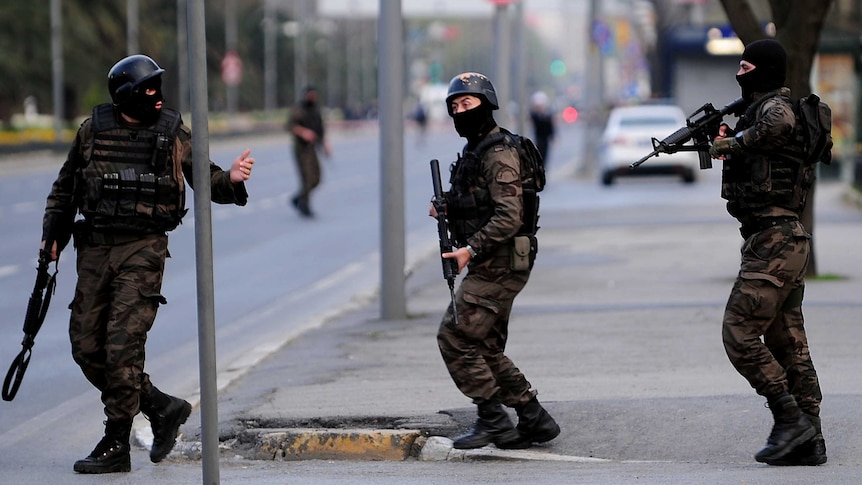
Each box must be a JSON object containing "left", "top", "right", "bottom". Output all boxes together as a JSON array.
[{"left": 599, "top": 104, "right": 700, "bottom": 185}]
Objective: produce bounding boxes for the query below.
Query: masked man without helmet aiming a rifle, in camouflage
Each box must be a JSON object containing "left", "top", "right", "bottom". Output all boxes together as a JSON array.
[{"left": 711, "top": 39, "right": 826, "bottom": 465}]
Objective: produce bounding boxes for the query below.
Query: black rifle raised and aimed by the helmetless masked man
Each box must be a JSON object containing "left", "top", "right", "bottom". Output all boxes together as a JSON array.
[{"left": 629, "top": 98, "right": 746, "bottom": 170}]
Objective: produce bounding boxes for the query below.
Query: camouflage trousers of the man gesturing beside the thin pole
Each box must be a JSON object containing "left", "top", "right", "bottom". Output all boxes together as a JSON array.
[{"left": 69, "top": 235, "right": 168, "bottom": 421}]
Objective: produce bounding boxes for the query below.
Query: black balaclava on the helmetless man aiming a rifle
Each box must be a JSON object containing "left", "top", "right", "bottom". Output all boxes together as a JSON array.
[{"left": 736, "top": 39, "right": 787, "bottom": 101}]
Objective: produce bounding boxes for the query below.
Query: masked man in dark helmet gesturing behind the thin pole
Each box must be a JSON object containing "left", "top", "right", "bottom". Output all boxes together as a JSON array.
[{"left": 42, "top": 55, "right": 254, "bottom": 473}]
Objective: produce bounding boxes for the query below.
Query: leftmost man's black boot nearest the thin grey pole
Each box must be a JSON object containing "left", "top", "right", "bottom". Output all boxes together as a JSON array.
[{"left": 141, "top": 386, "right": 192, "bottom": 463}]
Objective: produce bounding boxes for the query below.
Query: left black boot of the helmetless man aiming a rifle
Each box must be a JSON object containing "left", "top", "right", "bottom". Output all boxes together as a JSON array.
[{"left": 754, "top": 392, "right": 817, "bottom": 463}]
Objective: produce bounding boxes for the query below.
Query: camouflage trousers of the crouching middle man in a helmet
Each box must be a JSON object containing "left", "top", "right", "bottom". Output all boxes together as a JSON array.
[{"left": 437, "top": 248, "right": 536, "bottom": 407}]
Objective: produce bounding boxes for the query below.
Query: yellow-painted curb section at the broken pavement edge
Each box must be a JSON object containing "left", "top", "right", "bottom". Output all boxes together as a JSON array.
[{"left": 254, "top": 428, "right": 421, "bottom": 461}]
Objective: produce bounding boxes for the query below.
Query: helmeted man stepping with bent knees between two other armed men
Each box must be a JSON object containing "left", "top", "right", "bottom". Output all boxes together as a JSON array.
[{"left": 431, "top": 72, "right": 560, "bottom": 449}]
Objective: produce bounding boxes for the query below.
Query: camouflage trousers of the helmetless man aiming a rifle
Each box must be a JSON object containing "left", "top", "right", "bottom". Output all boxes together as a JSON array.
[{"left": 722, "top": 221, "right": 822, "bottom": 416}]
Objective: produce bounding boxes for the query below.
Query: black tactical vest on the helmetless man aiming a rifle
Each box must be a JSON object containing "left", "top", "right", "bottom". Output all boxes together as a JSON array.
[{"left": 721, "top": 96, "right": 814, "bottom": 217}]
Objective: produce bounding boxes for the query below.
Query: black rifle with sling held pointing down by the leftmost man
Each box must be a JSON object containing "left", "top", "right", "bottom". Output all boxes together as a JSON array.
[{"left": 3, "top": 238, "right": 62, "bottom": 401}]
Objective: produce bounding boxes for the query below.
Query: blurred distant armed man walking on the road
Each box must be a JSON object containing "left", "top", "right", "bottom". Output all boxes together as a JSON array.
[{"left": 287, "top": 86, "right": 332, "bottom": 217}]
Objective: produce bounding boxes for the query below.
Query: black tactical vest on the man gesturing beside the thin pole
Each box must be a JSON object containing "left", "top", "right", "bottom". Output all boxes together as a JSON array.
[{"left": 81, "top": 104, "right": 186, "bottom": 234}]
